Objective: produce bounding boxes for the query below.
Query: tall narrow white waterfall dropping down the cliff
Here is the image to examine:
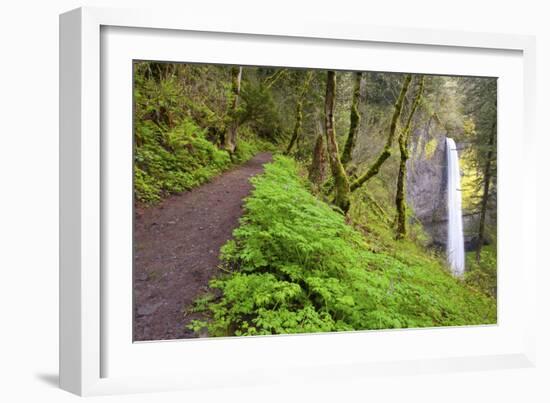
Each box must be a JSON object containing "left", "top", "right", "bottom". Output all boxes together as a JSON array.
[{"left": 446, "top": 137, "right": 464, "bottom": 276}]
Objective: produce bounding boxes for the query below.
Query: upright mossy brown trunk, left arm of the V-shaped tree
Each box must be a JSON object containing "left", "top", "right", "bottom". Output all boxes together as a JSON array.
[{"left": 325, "top": 70, "right": 350, "bottom": 213}]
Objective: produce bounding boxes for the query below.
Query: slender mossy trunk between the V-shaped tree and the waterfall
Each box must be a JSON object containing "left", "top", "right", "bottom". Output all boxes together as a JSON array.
[{"left": 395, "top": 76, "right": 424, "bottom": 239}]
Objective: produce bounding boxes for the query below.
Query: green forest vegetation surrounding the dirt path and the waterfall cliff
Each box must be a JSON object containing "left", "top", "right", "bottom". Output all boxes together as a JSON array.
[{"left": 134, "top": 62, "right": 497, "bottom": 336}]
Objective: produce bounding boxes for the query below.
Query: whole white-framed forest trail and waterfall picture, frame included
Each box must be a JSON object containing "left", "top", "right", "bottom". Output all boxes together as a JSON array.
[{"left": 60, "top": 8, "right": 536, "bottom": 395}]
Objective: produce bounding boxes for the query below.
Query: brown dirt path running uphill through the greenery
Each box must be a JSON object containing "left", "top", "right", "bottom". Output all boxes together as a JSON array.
[{"left": 133, "top": 153, "right": 272, "bottom": 341}]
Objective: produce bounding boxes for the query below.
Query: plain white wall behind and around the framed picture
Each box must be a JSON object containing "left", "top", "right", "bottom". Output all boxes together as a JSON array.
[{"left": 0, "top": 0, "right": 550, "bottom": 402}]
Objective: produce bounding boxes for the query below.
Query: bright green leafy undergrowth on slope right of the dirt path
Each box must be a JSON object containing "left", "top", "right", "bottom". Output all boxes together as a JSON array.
[{"left": 190, "top": 156, "right": 496, "bottom": 336}]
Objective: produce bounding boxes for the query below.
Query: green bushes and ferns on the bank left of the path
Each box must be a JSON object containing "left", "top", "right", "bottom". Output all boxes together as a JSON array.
[{"left": 134, "top": 62, "right": 272, "bottom": 204}]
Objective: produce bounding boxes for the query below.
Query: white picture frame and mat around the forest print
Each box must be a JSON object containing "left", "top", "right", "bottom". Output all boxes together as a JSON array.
[{"left": 60, "top": 8, "right": 536, "bottom": 395}]
